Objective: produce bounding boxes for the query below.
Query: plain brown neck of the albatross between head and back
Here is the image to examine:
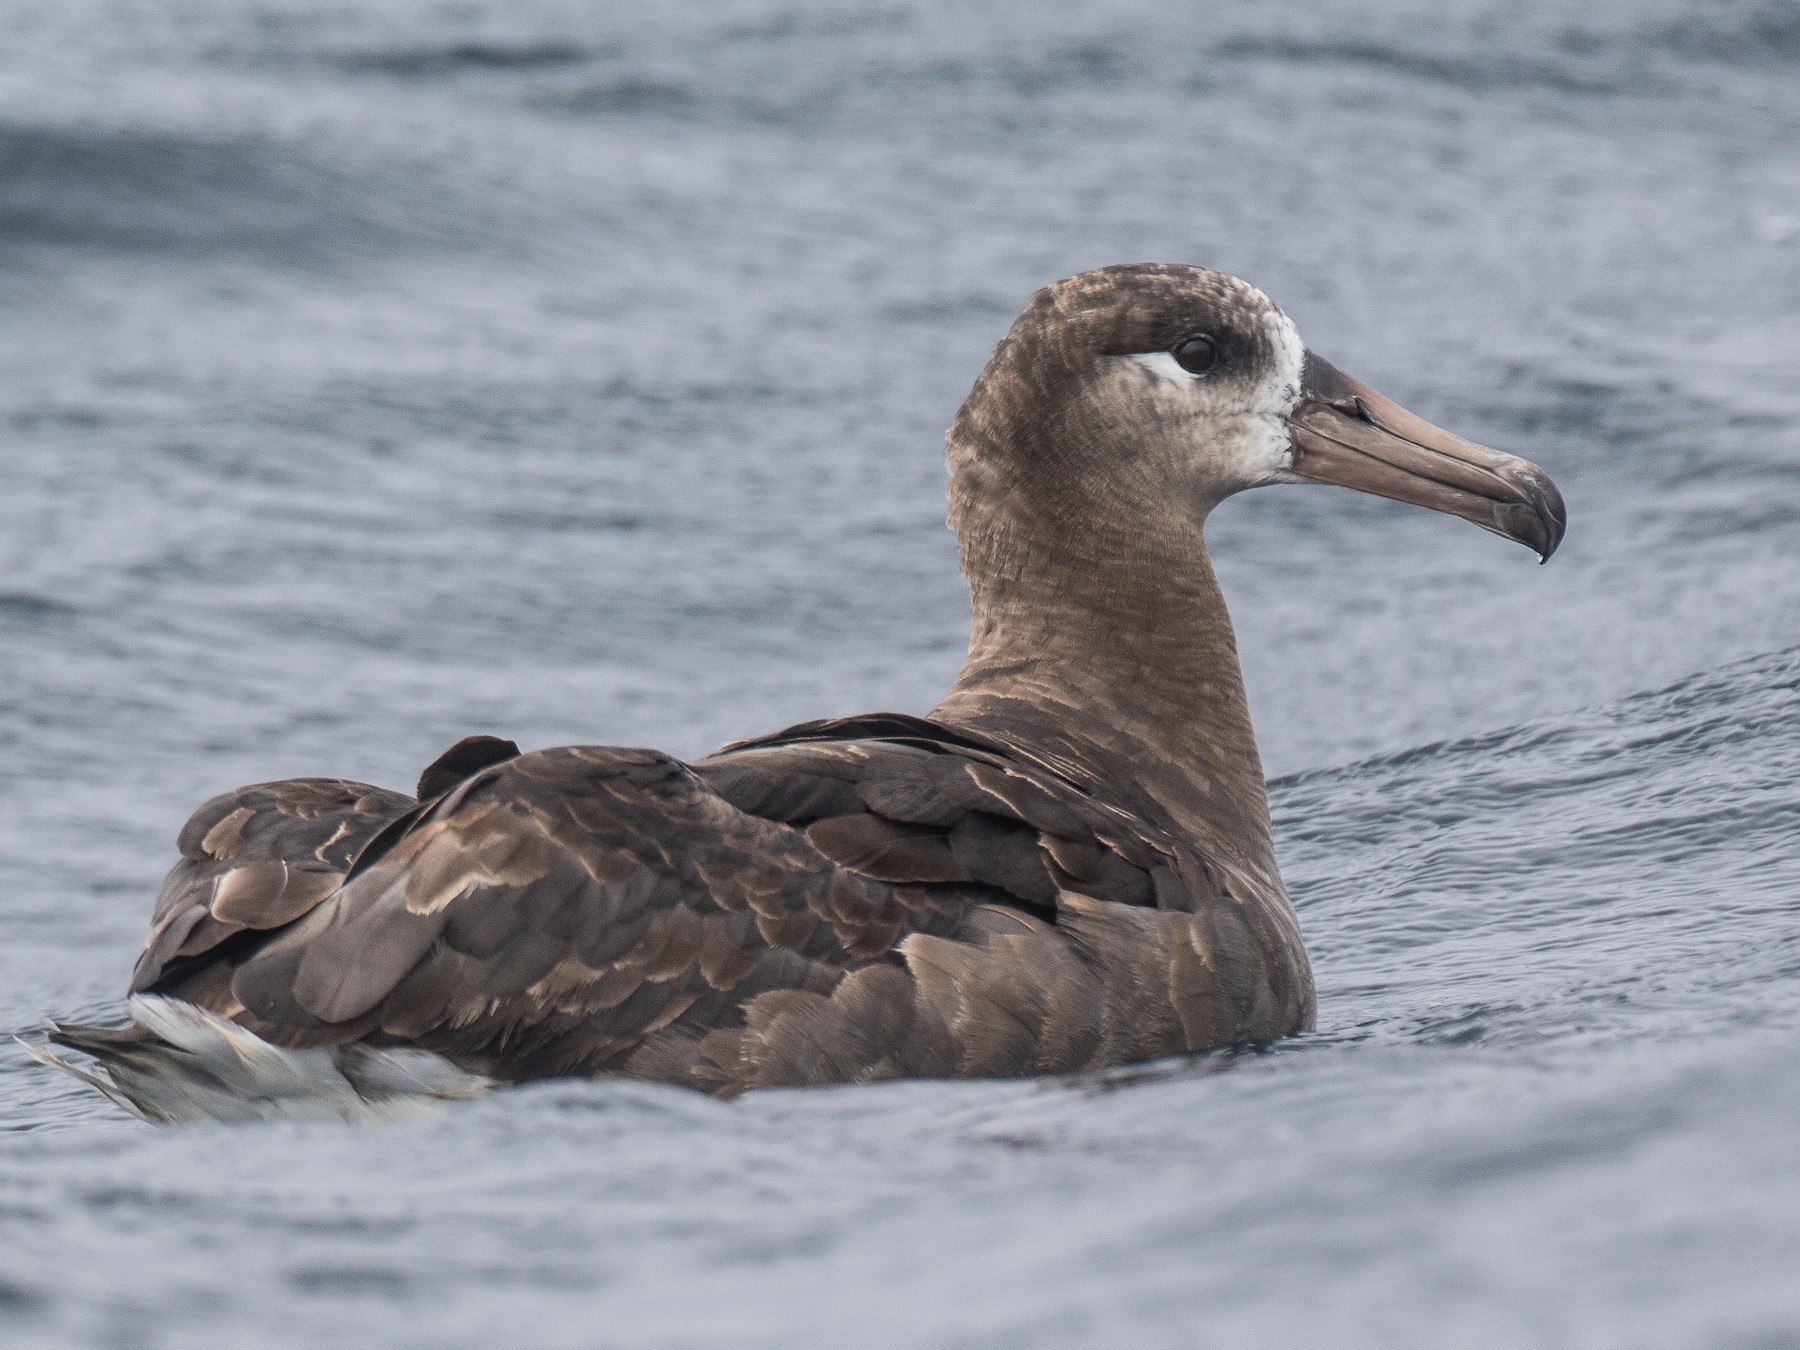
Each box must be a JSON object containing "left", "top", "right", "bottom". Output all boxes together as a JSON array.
[{"left": 932, "top": 486, "right": 1280, "bottom": 884}]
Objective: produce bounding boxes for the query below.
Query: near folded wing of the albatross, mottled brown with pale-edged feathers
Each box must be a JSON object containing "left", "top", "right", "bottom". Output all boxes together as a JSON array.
[{"left": 221, "top": 747, "right": 943, "bottom": 1076}]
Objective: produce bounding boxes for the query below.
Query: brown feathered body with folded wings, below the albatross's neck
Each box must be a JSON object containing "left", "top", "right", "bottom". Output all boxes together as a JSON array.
[{"left": 123, "top": 715, "right": 1310, "bottom": 1093}]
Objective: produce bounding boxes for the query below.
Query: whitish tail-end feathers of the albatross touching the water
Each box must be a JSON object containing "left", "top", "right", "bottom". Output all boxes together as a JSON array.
[{"left": 20, "top": 994, "right": 495, "bottom": 1125}]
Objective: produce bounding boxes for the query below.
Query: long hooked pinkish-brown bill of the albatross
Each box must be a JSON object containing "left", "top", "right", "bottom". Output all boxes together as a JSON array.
[{"left": 1287, "top": 351, "right": 1566, "bottom": 562}]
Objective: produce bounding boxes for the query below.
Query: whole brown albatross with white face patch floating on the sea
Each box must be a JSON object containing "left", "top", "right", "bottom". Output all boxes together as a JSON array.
[{"left": 38, "top": 265, "right": 1564, "bottom": 1121}]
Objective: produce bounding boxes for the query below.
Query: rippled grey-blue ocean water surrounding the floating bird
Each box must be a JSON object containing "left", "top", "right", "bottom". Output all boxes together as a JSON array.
[{"left": 0, "top": 0, "right": 1800, "bottom": 1350}]
